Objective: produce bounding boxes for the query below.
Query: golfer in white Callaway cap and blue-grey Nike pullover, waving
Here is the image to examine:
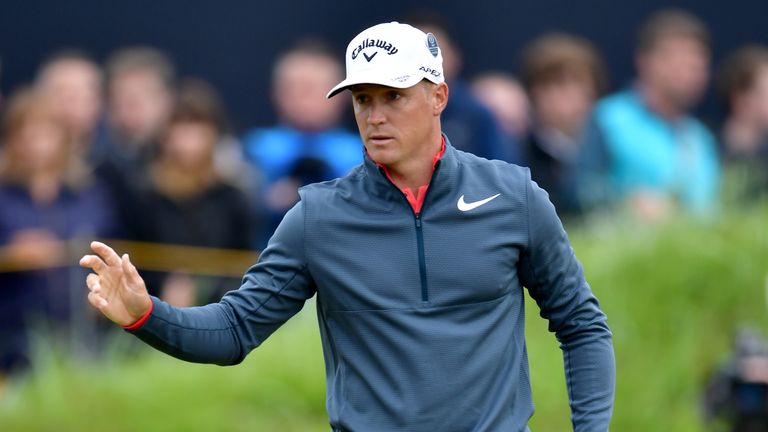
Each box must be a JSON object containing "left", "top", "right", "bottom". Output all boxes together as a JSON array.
[{"left": 81, "top": 23, "right": 614, "bottom": 431}]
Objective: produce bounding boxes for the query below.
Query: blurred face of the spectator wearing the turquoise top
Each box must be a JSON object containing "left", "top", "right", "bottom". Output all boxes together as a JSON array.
[{"left": 638, "top": 35, "right": 709, "bottom": 110}]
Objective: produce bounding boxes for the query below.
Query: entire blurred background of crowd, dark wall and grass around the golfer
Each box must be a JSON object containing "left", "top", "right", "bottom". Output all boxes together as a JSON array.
[{"left": 0, "top": 0, "right": 768, "bottom": 431}]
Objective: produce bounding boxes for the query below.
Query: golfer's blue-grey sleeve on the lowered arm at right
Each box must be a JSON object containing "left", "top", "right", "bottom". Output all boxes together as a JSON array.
[{"left": 519, "top": 170, "right": 615, "bottom": 432}]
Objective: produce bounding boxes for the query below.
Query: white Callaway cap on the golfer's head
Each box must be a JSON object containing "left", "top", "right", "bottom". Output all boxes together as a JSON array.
[{"left": 326, "top": 21, "right": 444, "bottom": 98}]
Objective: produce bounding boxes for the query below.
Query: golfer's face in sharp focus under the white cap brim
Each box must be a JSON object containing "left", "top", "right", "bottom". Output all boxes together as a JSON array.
[{"left": 351, "top": 81, "right": 448, "bottom": 167}]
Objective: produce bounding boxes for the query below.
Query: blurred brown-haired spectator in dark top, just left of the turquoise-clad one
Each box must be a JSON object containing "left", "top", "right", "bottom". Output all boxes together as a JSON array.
[{"left": 522, "top": 33, "right": 606, "bottom": 218}]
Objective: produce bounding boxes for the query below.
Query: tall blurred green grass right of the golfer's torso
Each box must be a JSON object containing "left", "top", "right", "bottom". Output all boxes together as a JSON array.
[{"left": 527, "top": 208, "right": 768, "bottom": 431}]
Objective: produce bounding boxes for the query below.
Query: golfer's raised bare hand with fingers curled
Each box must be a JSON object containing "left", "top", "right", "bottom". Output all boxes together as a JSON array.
[{"left": 80, "top": 241, "right": 152, "bottom": 326}]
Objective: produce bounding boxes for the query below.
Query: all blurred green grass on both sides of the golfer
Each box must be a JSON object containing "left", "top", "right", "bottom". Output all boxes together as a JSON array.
[{"left": 0, "top": 207, "right": 768, "bottom": 432}]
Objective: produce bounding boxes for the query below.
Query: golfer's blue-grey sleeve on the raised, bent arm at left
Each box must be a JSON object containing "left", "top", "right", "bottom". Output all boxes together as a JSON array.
[{"left": 131, "top": 201, "right": 316, "bottom": 365}]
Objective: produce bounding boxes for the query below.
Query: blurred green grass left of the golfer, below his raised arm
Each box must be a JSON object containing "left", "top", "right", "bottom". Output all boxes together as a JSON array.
[{"left": 0, "top": 305, "right": 328, "bottom": 432}]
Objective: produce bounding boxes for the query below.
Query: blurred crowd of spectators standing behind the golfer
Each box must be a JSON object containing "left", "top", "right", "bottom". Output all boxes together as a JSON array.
[{"left": 0, "top": 10, "right": 768, "bottom": 372}]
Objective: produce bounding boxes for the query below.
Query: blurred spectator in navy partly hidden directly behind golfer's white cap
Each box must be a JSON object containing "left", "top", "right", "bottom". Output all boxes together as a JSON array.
[{"left": 405, "top": 10, "right": 510, "bottom": 162}]
